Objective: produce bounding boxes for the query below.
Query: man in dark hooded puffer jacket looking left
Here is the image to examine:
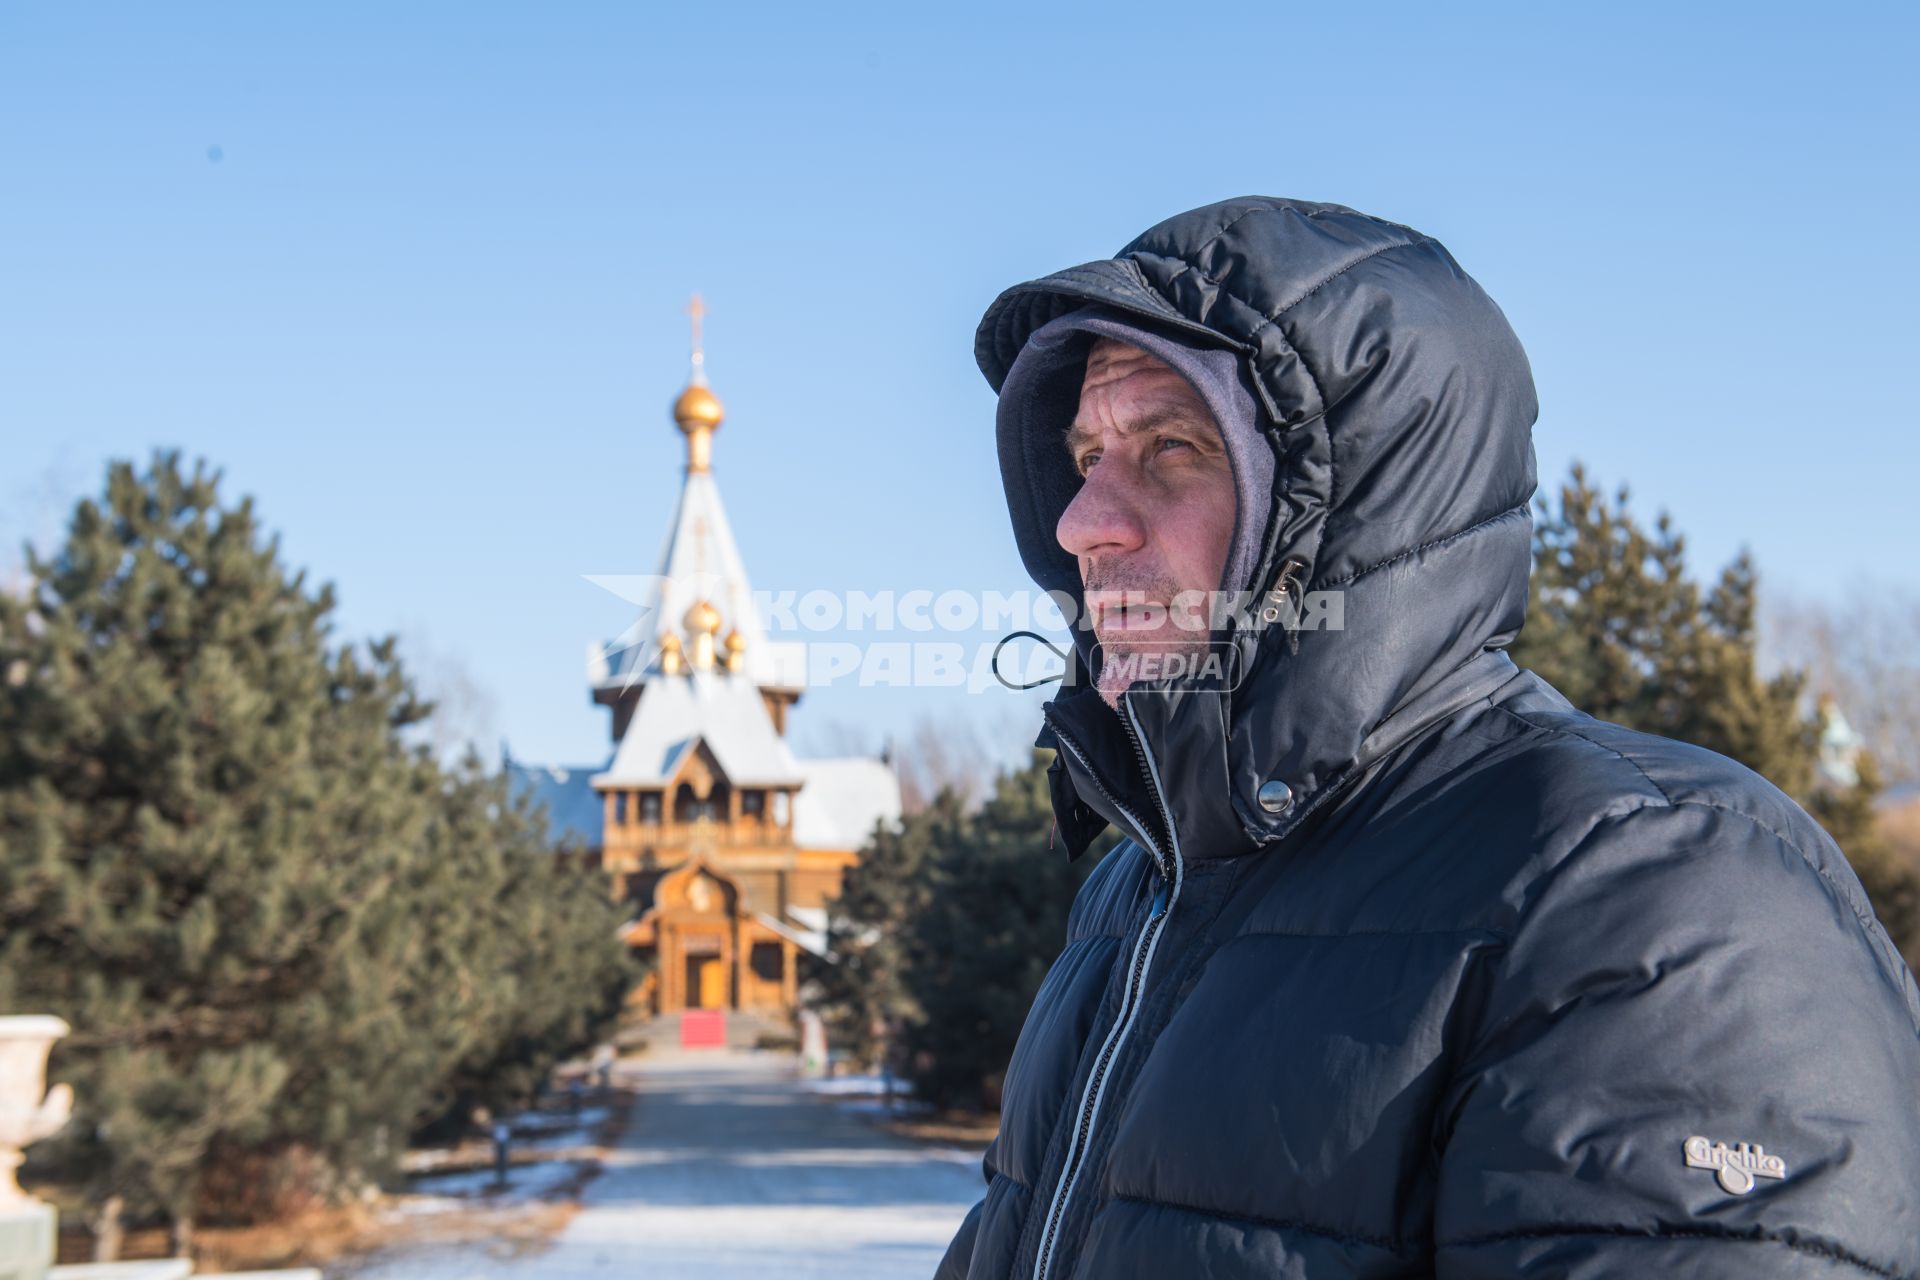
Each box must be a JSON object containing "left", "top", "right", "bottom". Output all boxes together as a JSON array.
[{"left": 939, "top": 198, "right": 1920, "bottom": 1280}]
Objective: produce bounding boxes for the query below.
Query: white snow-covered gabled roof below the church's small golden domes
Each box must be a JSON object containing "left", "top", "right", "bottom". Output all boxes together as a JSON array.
[{"left": 593, "top": 672, "right": 803, "bottom": 787}]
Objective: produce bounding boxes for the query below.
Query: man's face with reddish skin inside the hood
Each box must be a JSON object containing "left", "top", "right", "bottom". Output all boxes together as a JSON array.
[{"left": 1056, "top": 338, "right": 1236, "bottom": 706}]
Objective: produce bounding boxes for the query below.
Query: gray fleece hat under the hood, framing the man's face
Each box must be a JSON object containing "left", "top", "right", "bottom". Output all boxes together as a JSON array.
[{"left": 998, "top": 307, "right": 1273, "bottom": 614}]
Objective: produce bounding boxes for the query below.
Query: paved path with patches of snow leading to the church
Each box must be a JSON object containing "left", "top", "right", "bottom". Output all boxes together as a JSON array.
[{"left": 365, "top": 1052, "right": 985, "bottom": 1280}]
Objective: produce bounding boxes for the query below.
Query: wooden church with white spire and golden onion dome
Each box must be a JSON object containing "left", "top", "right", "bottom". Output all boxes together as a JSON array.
[{"left": 507, "top": 299, "right": 900, "bottom": 1019}]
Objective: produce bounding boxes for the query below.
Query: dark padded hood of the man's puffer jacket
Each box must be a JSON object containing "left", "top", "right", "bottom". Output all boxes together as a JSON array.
[{"left": 975, "top": 196, "right": 1538, "bottom": 871}]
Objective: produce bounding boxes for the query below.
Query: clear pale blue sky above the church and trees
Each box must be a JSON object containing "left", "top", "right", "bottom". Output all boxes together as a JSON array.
[{"left": 0, "top": 0, "right": 1920, "bottom": 762}]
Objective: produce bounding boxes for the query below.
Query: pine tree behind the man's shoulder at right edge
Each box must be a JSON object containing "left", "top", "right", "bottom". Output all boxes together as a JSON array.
[{"left": 1513, "top": 464, "right": 1920, "bottom": 954}]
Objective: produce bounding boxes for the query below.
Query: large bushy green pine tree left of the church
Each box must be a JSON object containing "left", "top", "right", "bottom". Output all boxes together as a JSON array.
[{"left": 0, "top": 453, "right": 620, "bottom": 1238}]
